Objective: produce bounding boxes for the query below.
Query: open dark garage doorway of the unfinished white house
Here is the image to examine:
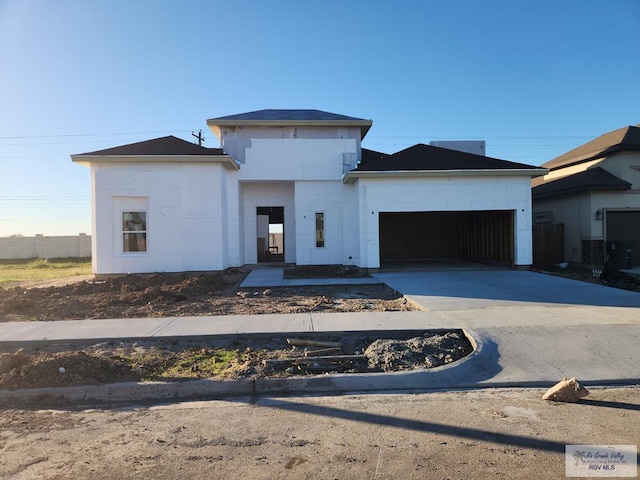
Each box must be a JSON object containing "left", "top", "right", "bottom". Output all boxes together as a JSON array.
[{"left": 379, "top": 210, "right": 514, "bottom": 265}]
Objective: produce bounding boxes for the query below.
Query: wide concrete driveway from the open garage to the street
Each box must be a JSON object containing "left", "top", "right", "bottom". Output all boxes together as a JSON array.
[{"left": 370, "top": 270, "right": 640, "bottom": 386}]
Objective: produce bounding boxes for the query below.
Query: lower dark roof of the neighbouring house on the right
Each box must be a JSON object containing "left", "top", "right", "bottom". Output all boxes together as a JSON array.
[{"left": 532, "top": 167, "right": 631, "bottom": 200}]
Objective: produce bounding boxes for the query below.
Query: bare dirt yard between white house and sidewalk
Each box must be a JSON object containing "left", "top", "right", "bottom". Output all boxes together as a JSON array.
[{"left": 0, "top": 268, "right": 415, "bottom": 322}]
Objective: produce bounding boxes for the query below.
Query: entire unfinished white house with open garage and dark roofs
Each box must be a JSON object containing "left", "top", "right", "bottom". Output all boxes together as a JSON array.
[{"left": 72, "top": 110, "right": 546, "bottom": 274}]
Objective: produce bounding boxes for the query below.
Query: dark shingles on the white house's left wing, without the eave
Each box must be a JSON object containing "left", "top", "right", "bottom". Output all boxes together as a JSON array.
[{"left": 78, "top": 135, "right": 223, "bottom": 156}]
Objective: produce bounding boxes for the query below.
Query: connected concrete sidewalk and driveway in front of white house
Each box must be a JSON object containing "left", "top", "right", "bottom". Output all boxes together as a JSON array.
[{"left": 0, "top": 271, "right": 640, "bottom": 402}]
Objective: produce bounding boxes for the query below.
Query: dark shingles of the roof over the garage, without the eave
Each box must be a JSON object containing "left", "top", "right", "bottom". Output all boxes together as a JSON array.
[{"left": 355, "top": 143, "right": 540, "bottom": 172}]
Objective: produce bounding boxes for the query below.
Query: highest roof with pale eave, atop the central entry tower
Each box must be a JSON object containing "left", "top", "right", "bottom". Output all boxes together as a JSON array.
[{"left": 207, "top": 109, "right": 373, "bottom": 138}]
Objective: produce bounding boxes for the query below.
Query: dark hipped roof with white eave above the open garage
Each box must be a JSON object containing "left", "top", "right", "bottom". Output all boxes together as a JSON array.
[{"left": 343, "top": 143, "right": 548, "bottom": 182}]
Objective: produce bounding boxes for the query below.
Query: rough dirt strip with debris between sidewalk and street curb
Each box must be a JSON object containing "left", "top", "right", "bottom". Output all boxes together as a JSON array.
[{"left": 0, "top": 330, "right": 472, "bottom": 390}]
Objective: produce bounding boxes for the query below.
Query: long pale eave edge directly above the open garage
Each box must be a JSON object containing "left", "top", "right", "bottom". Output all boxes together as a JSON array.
[{"left": 342, "top": 168, "right": 549, "bottom": 183}]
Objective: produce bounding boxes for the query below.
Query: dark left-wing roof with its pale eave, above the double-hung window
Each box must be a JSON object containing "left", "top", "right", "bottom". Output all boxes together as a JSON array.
[{"left": 71, "top": 135, "right": 239, "bottom": 170}]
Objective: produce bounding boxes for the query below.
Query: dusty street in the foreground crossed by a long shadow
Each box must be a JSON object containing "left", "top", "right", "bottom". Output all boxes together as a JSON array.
[{"left": 5, "top": 387, "right": 640, "bottom": 480}]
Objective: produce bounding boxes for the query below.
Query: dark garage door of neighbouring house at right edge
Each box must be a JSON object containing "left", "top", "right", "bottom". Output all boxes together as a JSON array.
[{"left": 604, "top": 209, "right": 640, "bottom": 269}]
